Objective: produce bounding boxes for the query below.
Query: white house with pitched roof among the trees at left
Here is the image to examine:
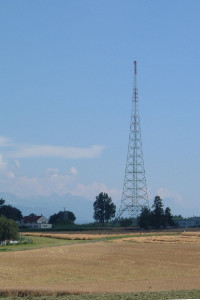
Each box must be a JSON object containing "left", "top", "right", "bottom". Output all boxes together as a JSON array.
[{"left": 21, "top": 215, "right": 52, "bottom": 229}]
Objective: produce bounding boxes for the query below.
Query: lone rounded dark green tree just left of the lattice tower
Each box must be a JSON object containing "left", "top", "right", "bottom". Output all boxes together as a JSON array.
[{"left": 93, "top": 192, "right": 116, "bottom": 224}]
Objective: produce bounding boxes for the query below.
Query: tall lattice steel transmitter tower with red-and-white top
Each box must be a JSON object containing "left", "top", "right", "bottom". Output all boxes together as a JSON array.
[{"left": 116, "top": 61, "right": 149, "bottom": 219}]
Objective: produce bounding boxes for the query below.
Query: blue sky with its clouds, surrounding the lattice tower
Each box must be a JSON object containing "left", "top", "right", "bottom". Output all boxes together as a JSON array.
[{"left": 0, "top": 0, "right": 200, "bottom": 215}]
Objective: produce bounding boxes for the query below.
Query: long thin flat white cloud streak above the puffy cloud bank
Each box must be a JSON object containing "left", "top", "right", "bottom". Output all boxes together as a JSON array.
[{"left": 8, "top": 145, "right": 104, "bottom": 159}]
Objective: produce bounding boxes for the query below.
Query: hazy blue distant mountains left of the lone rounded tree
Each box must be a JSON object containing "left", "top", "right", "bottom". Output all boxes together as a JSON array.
[{"left": 0, "top": 193, "right": 94, "bottom": 223}]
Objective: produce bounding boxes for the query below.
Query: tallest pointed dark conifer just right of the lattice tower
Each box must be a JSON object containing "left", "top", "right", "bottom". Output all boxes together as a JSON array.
[{"left": 152, "top": 196, "right": 165, "bottom": 228}]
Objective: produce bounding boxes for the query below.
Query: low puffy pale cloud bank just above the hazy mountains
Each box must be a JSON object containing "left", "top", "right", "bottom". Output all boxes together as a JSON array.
[{"left": 0, "top": 167, "right": 121, "bottom": 202}]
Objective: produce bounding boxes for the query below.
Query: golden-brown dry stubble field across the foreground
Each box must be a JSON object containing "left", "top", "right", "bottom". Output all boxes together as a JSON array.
[{"left": 0, "top": 232, "right": 200, "bottom": 294}]
